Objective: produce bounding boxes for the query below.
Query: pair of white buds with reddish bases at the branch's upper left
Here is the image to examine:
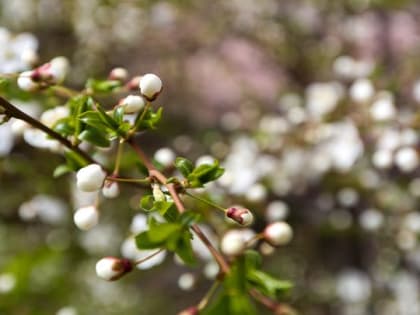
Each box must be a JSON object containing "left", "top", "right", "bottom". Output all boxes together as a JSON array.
[{"left": 17, "top": 57, "right": 69, "bottom": 91}]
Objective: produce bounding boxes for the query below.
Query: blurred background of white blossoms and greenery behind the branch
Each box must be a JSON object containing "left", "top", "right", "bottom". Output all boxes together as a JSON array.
[{"left": 0, "top": 0, "right": 420, "bottom": 315}]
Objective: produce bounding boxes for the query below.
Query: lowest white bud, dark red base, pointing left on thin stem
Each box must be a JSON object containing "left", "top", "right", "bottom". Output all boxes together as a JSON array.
[{"left": 96, "top": 257, "right": 133, "bottom": 281}]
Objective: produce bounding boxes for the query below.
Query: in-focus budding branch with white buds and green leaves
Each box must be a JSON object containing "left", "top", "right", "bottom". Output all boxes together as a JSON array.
[{"left": 0, "top": 30, "right": 294, "bottom": 315}]
